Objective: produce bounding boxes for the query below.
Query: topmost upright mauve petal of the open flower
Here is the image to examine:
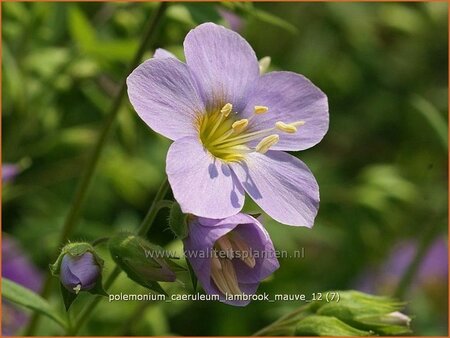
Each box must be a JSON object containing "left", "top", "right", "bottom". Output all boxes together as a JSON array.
[{"left": 184, "top": 23, "right": 259, "bottom": 111}]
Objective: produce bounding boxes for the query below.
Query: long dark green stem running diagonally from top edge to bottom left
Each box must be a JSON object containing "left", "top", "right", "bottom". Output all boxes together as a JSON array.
[{"left": 24, "top": 2, "right": 168, "bottom": 336}]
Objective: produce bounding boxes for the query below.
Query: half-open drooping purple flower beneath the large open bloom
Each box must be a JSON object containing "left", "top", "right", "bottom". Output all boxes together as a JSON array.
[{"left": 184, "top": 213, "right": 279, "bottom": 306}]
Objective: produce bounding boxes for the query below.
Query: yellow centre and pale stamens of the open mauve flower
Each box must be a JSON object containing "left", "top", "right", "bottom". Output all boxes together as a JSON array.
[{"left": 198, "top": 103, "right": 305, "bottom": 162}]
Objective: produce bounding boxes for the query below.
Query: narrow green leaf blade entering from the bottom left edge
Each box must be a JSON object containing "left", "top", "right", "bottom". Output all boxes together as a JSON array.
[{"left": 2, "top": 278, "right": 67, "bottom": 328}]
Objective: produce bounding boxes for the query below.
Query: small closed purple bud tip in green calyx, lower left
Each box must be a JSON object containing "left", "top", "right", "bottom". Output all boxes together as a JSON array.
[{"left": 60, "top": 252, "right": 101, "bottom": 294}]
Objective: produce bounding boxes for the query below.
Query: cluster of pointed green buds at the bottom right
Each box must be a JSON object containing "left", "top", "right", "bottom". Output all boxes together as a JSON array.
[{"left": 256, "top": 290, "right": 411, "bottom": 336}]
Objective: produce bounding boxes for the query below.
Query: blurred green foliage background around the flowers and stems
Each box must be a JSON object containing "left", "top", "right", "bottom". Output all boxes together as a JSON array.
[{"left": 1, "top": 2, "right": 448, "bottom": 335}]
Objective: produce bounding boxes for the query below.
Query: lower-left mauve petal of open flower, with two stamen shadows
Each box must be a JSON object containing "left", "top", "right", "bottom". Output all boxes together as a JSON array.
[{"left": 166, "top": 137, "right": 244, "bottom": 218}]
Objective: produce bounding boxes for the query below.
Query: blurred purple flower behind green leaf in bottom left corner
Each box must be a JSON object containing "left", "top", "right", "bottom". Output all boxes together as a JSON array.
[{"left": 2, "top": 234, "right": 42, "bottom": 336}]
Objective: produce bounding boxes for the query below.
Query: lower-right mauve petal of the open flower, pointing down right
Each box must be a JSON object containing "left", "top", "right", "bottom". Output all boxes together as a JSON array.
[{"left": 232, "top": 150, "right": 319, "bottom": 227}]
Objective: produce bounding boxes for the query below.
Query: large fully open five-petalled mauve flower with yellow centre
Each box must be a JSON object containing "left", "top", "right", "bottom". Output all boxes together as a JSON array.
[{"left": 127, "top": 23, "right": 328, "bottom": 227}]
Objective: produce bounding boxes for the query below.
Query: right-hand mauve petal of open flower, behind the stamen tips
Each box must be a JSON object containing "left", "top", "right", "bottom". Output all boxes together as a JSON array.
[{"left": 243, "top": 72, "right": 329, "bottom": 151}]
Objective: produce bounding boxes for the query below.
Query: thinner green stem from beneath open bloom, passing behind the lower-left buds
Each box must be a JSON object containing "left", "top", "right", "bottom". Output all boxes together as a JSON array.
[{"left": 68, "top": 178, "right": 169, "bottom": 336}]
